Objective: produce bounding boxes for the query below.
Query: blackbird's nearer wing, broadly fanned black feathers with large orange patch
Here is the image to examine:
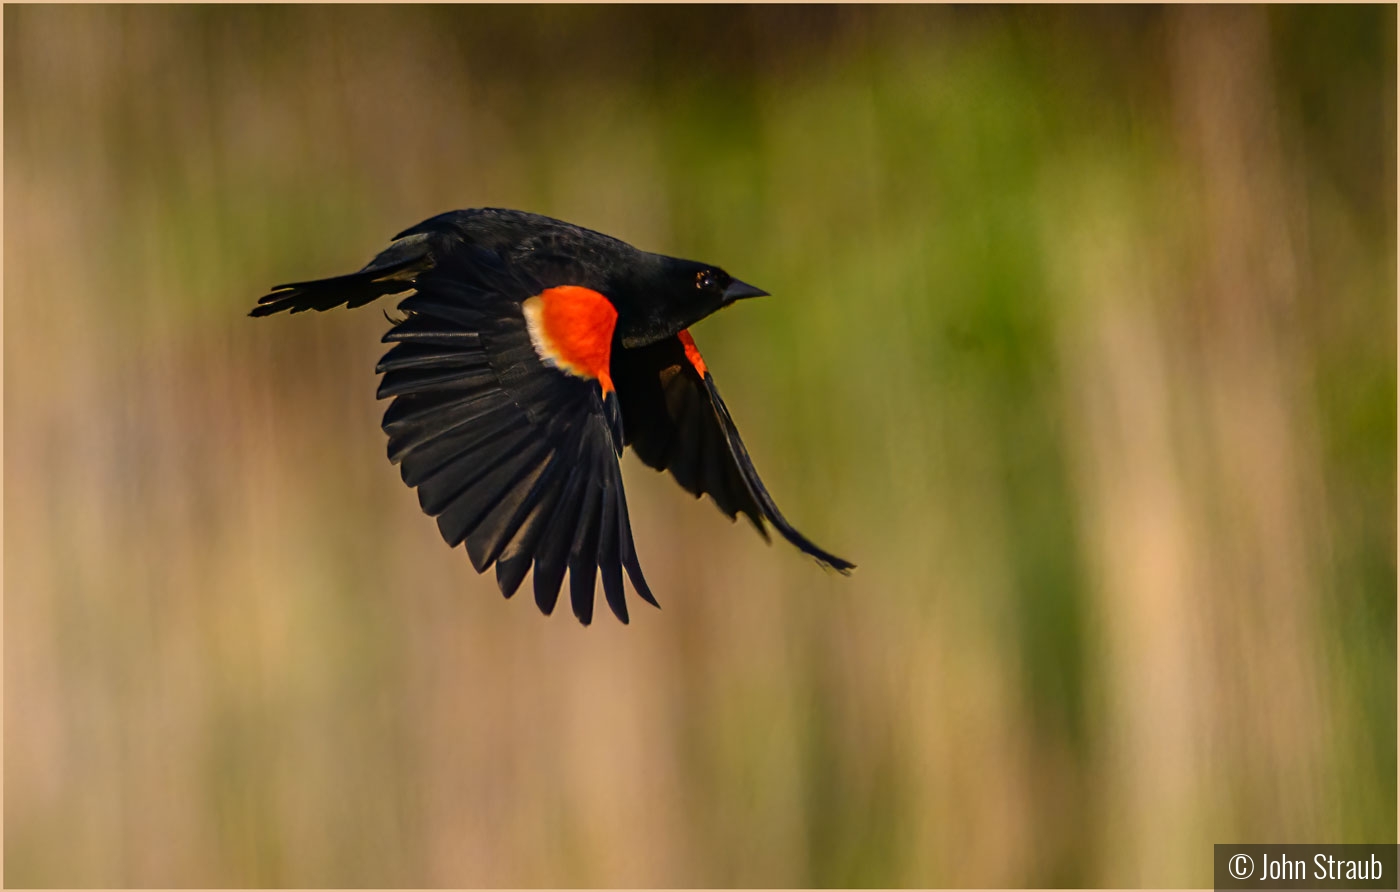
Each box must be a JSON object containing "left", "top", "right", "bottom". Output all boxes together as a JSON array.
[{"left": 378, "top": 246, "right": 657, "bottom": 625}]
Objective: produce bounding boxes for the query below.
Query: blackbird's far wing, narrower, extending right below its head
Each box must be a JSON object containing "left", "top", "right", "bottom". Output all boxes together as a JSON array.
[{"left": 612, "top": 332, "right": 855, "bottom": 573}]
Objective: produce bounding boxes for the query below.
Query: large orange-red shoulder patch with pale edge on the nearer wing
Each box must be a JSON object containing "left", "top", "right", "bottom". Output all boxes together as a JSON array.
[{"left": 521, "top": 284, "right": 617, "bottom": 393}]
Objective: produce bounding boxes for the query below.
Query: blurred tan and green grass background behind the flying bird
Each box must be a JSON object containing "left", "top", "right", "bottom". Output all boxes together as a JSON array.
[{"left": 4, "top": 6, "right": 1396, "bottom": 886}]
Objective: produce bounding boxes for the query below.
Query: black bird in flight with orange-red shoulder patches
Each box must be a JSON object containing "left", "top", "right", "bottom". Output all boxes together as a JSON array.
[{"left": 251, "top": 209, "right": 854, "bottom": 625}]
